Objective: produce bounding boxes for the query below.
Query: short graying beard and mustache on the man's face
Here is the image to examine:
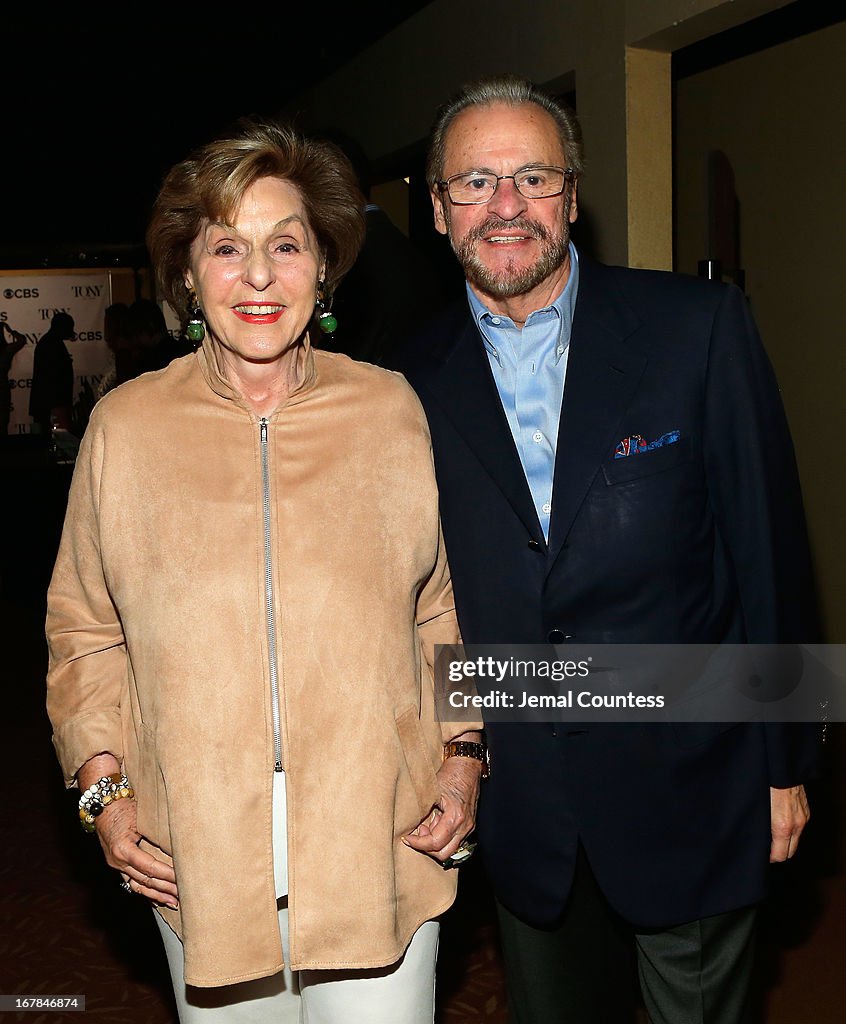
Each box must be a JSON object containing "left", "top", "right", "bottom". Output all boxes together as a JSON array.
[{"left": 450, "top": 218, "right": 569, "bottom": 299}]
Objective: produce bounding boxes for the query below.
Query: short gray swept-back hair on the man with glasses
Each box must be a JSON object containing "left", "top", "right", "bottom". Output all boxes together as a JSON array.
[{"left": 426, "top": 75, "right": 585, "bottom": 188}]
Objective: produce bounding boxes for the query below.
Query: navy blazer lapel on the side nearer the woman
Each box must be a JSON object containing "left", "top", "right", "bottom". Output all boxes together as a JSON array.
[{"left": 426, "top": 313, "right": 544, "bottom": 544}]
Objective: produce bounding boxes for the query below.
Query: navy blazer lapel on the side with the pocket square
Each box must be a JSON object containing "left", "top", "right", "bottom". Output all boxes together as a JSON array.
[{"left": 549, "top": 261, "right": 646, "bottom": 567}]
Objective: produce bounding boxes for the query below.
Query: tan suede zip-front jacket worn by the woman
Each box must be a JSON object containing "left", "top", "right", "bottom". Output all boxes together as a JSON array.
[{"left": 47, "top": 343, "right": 480, "bottom": 986}]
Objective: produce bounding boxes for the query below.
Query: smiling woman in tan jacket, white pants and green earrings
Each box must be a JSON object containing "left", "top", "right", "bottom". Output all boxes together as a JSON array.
[{"left": 47, "top": 122, "right": 484, "bottom": 1024}]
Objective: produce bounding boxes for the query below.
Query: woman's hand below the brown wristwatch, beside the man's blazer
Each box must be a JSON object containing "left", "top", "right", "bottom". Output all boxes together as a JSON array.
[{"left": 403, "top": 757, "right": 481, "bottom": 862}]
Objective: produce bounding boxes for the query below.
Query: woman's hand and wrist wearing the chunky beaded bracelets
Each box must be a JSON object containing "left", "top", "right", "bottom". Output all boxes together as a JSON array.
[{"left": 77, "top": 754, "right": 179, "bottom": 909}]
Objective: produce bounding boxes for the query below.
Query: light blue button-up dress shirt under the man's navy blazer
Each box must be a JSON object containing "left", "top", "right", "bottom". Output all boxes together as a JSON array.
[{"left": 467, "top": 242, "right": 579, "bottom": 540}]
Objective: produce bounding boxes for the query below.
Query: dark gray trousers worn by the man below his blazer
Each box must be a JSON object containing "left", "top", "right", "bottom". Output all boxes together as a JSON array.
[{"left": 497, "top": 856, "right": 757, "bottom": 1024}]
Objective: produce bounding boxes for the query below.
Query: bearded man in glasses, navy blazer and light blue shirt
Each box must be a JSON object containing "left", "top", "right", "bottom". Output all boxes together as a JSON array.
[{"left": 396, "top": 76, "right": 817, "bottom": 1024}]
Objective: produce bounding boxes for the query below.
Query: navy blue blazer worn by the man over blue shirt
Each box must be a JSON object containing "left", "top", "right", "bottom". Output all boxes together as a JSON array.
[{"left": 394, "top": 258, "right": 819, "bottom": 927}]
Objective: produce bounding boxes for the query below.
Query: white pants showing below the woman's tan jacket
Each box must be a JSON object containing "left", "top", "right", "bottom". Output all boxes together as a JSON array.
[{"left": 154, "top": 899, "right": 439, "bottom": 1024}]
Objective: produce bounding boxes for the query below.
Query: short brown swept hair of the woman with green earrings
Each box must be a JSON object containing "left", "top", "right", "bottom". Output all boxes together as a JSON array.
[{"left": 146, "top": 119, "right": 366, "bottom": 328}]
